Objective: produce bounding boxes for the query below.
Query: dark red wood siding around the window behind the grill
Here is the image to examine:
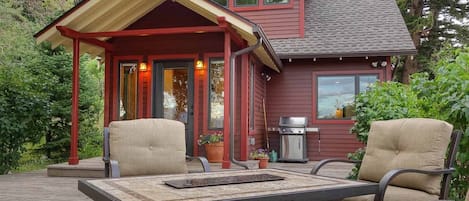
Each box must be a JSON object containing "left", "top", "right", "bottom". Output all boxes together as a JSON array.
[{"left": 267, "top": 58, "right": 386, "bottom": 160}]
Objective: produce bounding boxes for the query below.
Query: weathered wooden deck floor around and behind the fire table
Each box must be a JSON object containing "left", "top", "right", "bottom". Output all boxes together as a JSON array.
[{"left": 0, "top": 158, "right": 352, "bottom": 201}]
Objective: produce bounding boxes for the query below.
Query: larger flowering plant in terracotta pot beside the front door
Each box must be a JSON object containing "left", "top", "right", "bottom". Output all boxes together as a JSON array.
[{"left": 198, "top": 131, "right": 223, "bottom": 163}]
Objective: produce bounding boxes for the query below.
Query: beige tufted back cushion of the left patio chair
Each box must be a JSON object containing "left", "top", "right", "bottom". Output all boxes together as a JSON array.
[{"left": 109, "top": 119, "right": 187, "bottom": 176}]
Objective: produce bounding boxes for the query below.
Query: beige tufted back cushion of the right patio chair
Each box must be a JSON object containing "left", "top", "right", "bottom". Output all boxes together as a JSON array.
[{"left": 358, "top": 118, "right": 453, "bottom": 195}]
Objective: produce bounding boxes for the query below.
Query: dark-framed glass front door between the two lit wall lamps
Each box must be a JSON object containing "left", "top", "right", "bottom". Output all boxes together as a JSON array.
[{"left": 153, "top": 60, "right": 194, "bottom": 155}]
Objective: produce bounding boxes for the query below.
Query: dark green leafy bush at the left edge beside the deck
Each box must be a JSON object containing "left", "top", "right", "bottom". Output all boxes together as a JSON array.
[{"left": 0, "top": 66, "right": 48, "bottom": 174}]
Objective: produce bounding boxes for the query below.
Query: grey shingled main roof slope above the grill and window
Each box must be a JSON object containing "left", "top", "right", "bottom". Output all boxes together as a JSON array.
[{"left": 270, "top": 0, "right": 416, "bottom": 58}]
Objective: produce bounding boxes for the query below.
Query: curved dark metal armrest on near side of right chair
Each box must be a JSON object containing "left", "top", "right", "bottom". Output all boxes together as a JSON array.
[{"left": 374, "top": 168, "right": 455, "bottom": 201}]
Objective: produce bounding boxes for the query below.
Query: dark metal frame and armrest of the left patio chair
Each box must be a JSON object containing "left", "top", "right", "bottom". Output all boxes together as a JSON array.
[{"left": 103, "top": 127, "right": 211, "bottom": 178}]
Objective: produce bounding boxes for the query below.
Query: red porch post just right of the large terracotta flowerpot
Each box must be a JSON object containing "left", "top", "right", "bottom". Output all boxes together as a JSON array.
[{"left": 221, "top": 31, "right": 231, "bottom": 169}]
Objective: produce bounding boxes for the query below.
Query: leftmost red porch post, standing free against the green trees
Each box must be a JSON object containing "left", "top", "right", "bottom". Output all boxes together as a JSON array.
[{"left": 68, "top": 38, "right": 80, "bottom": 165}]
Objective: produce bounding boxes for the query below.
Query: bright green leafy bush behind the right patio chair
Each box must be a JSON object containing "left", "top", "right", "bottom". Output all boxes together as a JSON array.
[{"left": 349, "top": 48, "right": 469, "bottom": 201}]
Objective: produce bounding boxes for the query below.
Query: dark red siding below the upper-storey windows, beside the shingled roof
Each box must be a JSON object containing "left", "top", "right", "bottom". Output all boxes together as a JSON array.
[{"left": 237, "top": 0, "right": 304, "bottom": 39}]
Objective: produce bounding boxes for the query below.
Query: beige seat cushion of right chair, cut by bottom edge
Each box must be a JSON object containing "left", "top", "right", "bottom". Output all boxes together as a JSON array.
[{"left": 343, "top": 186, "right": 438, "bottom": 201}]
